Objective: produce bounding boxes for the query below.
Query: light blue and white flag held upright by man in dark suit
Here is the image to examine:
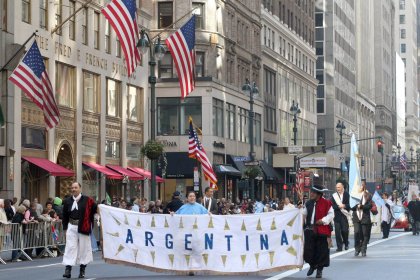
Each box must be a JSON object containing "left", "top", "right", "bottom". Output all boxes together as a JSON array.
[{"left": 349, "top": 134, "right": 362, "bottom": 207}]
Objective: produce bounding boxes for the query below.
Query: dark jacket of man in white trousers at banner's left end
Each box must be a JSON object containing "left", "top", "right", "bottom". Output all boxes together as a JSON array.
[{"left": 63, "top": 195, "right": 97, "bottom": 235}]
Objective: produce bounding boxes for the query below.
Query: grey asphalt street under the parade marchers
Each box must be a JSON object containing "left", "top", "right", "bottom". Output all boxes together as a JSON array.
[{"left": 0, "top": 232, "right": 420, "bottom": 280}]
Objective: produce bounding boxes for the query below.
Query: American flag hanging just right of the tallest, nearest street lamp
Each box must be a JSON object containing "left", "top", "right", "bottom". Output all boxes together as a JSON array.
[{"left": 166, "top": 15, "right": 195, "bottom": 98}]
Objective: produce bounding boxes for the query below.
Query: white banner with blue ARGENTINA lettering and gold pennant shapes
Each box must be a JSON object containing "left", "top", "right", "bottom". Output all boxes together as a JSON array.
[{"left": 99, "top": 205, "right": 303, "bottom": 274}]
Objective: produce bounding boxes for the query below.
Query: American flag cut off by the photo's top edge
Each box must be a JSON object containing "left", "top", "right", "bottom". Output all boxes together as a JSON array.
[{"left": 101, "top": 0, "right": 140, "bottom": 76}]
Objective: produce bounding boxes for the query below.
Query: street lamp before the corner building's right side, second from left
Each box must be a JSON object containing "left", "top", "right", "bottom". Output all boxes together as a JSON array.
[{"left": 242, "top": 79, "right": 259, "bottom": 199}]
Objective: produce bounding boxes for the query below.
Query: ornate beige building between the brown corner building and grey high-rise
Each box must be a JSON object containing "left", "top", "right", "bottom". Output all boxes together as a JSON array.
[{"left": 261, "top": 0, "right": 317, "bottom": 195}]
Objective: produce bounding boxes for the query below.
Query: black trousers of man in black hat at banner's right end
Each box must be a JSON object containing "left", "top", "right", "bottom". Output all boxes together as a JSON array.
[{"left": 303, "top": 230, "right": 330, "bottom": 270}]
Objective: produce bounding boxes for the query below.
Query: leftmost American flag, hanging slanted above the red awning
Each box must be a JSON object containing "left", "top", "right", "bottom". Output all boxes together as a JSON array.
[{"left": 9, "top": 41, "right": 60, "bottom": 129}]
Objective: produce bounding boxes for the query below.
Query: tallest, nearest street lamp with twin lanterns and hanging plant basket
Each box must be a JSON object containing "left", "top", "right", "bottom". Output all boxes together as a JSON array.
[{"left": 137, "top": 30, "right": 166, "bottom": 201}]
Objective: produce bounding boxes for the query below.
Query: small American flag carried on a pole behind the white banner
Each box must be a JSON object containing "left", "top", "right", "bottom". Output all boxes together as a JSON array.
[{"left": 188, "top": 120, "right": 217, "bottom": 188}]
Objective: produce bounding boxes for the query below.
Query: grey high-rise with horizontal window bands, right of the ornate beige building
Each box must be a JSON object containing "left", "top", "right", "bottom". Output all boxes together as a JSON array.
[{"left": 315, "top": 0, "right": 359, "bottom": 187}]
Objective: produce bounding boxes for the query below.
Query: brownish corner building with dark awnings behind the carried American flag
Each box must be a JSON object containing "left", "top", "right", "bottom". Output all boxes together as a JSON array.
[{"left": 149, "top": 0, "right": 265, "bottom": 199}]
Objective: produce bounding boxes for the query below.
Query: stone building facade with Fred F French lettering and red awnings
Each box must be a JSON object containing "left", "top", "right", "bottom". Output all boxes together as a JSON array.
[{"left": 0, "top": 0, "right": 150, "bottom": 202}]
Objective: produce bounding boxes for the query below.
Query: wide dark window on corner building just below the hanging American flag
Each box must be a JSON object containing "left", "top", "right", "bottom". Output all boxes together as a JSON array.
[{"left": 157, "top": 97, "right": 202, "bottom": 135}]
